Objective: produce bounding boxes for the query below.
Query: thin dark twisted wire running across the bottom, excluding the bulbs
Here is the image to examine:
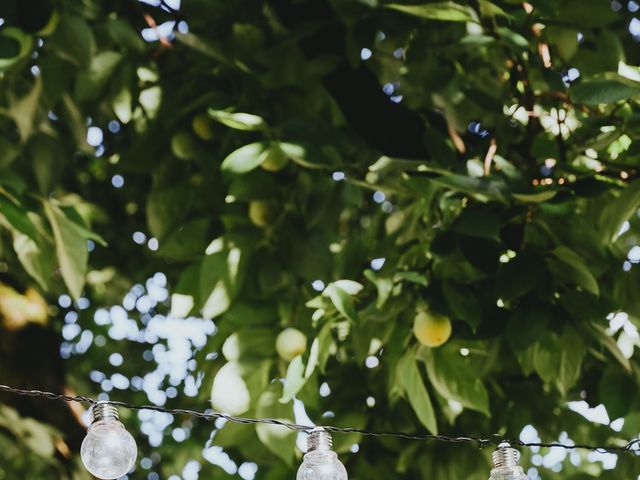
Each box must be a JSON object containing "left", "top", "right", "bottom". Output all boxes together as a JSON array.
[{"left": 0, "top": 384, "right": 640, "bottom": 455}]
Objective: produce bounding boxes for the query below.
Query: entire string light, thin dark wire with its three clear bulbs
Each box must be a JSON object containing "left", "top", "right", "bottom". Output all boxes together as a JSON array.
[{"left": 0, "top": 384, "right": 640, "bottom": 480}]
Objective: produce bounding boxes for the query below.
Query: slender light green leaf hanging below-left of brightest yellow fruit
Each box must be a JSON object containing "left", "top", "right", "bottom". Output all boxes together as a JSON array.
[{"left": 397, "top": 351, "right": 438, "bottom": 435}]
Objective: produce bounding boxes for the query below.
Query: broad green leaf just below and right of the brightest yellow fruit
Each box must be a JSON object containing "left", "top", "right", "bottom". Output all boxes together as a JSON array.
[{"left": 420, "top": 348, "right": 491, "bottom": 417}]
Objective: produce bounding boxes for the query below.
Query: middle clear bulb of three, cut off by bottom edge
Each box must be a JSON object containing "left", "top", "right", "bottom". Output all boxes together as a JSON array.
[{"left": 296, "top": 427, "right": 348, "bottom": 480}]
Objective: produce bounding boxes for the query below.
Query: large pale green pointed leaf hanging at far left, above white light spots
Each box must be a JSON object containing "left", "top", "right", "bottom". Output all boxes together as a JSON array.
[{"left": 44, "top": 201, "right": 89, "bottom": 299}]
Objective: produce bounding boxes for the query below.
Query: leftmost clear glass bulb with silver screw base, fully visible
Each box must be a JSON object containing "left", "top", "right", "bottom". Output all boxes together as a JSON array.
[{"left": 80, "top": 402, "right": 138, "bottom": 480}]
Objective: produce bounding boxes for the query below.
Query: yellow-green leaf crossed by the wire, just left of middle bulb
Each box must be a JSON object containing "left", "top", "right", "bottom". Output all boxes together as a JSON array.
[{"left": 256, "top": 382, "right": 296, "bottom": 465}]
